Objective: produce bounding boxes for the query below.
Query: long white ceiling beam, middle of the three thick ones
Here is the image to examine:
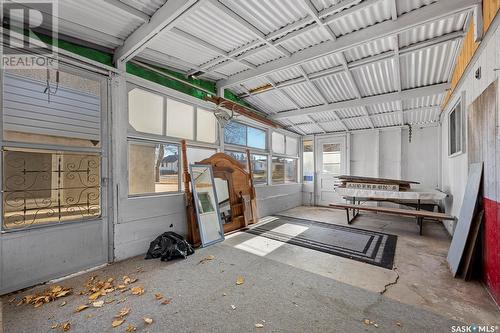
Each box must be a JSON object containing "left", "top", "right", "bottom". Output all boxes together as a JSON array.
[{"left": 217, "top": 0, "right": 481, "bottom": 87}]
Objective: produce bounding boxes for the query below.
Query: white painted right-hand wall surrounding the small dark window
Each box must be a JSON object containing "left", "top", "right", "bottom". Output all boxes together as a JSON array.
[{"left": 441, "top": 16, "right": 500, "bottom": 234}]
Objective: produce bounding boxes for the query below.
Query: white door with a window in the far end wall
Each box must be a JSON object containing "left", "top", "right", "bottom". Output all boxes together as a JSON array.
[{"left": 316, "top": 136, "right": 347, "bottom": 206}]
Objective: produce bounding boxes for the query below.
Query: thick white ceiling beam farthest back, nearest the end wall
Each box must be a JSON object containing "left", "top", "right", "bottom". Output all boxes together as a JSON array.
[{"left": 271, "top": 83, "right": 451, "bottom": 119}]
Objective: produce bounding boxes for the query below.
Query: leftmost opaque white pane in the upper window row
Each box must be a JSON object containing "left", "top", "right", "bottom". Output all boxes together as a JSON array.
[{"left": 128, "top": 88, "right": 163, "bottom": 135}]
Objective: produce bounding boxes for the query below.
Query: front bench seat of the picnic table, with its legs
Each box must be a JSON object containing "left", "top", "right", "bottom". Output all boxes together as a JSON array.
[{"left": 330, "top": 203, "right": 455, "bottom": 235}]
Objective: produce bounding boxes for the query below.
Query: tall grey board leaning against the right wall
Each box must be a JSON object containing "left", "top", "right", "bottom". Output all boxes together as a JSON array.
[{"left": 447, "top": 163, "right": 483, "bottom": 276}]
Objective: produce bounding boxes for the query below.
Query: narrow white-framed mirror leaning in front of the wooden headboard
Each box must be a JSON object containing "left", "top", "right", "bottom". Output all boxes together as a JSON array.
[{"left": 189, "top": 164, "right": 224, "bottom": 247}]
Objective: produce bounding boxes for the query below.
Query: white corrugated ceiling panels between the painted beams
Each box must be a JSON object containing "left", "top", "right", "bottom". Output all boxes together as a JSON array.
[{"left": 16, "top": 0, "right": 470, "bottom": 134}]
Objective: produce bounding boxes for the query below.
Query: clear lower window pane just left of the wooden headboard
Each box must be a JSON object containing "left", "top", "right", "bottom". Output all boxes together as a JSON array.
[{"left": 128, "top": 142, "right": 179, "bottom": 195}]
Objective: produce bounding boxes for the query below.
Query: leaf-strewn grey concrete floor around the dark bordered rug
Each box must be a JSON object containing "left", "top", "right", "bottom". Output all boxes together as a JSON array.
[{"left": 2, "top": 207, "right": 500, "bottom": 333}]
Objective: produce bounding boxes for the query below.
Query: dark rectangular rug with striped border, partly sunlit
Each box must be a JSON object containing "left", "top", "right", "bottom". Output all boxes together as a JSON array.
[{"left": 245, "top": 215, "right": 397, "bottom": 269}]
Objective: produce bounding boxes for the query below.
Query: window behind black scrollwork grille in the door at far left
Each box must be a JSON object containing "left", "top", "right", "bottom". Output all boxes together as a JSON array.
[{"left": 3, "top": 148, "right": 101, "bottom": 229}]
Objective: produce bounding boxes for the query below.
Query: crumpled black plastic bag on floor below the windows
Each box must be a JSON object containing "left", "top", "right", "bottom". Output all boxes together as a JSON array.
[{"left": 145, "top": 231, "right": 194, "bottom": 261}]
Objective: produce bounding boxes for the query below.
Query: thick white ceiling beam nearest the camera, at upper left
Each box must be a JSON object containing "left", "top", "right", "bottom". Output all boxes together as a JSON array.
[{"left": 114, "top": 0, "right": 199, "bottom": 64}]
